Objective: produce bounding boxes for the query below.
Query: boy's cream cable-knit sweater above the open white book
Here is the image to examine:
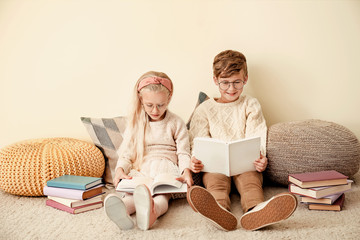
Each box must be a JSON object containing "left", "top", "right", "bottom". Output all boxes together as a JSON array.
[{"left": 190, "top": 95, "right": 267, "bottom": 156}]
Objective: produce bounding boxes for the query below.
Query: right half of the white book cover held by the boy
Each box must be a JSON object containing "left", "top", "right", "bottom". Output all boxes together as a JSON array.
[{"left": 229, "top": 137, "right": 260, "bottom": 176}]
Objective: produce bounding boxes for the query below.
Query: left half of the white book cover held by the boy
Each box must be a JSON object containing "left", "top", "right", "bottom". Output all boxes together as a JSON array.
[{"left": 194, "top": 138, "right": 229, "bottom": 175}]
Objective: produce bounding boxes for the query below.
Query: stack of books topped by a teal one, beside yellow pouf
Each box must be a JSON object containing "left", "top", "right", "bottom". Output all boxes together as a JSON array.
[{"left": 44, "top": 175, "right": 103, "bottom": 214}]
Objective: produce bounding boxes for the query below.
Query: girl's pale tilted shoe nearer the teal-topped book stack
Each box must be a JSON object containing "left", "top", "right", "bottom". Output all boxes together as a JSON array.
[{"left": 104, "top": 193, "right": 135, "bottom": 230}]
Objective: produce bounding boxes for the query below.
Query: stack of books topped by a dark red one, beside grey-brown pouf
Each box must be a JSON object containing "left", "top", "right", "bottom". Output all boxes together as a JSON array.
[{"left": 289, "top": 170, "right": 352, "bottom": 211}]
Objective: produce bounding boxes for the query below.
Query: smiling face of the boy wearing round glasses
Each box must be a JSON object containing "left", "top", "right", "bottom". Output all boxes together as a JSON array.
[{"left": 214, "top": 70, "right": 248, "bottom": 103}]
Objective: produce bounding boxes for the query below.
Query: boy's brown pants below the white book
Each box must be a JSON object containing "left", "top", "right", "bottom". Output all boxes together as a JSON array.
[{"left": 203, "top": 171, "right": 264, "bottom": 213}]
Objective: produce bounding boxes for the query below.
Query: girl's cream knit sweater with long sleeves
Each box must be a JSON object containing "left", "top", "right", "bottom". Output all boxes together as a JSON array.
[{"left": 115, "top": 110, "right": 190, "bottom": 175}]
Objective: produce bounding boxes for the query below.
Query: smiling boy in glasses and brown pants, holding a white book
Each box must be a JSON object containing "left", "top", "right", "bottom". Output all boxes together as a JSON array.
[{"left": 187, "top": 50, "right": 297, "bottom": 231}]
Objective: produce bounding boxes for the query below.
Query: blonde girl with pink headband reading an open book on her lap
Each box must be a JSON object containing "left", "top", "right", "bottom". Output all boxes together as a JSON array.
[{"left": 104, "top": 71, "right": 193, "bottom": 230}]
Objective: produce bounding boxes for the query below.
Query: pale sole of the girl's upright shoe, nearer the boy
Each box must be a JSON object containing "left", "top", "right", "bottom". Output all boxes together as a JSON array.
[{"left": 134, "top": 185, "right": 151, "bottom": 230}]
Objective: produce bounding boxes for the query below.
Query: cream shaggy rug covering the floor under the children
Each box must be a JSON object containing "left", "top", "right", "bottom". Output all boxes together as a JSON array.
[{"left": 0, "top": 172, "right": 360, "bottom": 240}]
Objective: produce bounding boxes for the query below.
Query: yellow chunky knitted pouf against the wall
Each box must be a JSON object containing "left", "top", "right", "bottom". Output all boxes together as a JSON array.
[{"left": 0, "top": 138, "right": 105, "bottom": 196}]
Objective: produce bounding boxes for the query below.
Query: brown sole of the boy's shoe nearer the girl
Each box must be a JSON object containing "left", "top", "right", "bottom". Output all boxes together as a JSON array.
[{"left": 187, "top": 186, "right": 237, "bottom": 231}]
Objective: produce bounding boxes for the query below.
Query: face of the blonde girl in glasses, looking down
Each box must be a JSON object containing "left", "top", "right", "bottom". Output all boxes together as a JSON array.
[{"left": 140, "top": 90, "right": 170, "bottom": 122}]
